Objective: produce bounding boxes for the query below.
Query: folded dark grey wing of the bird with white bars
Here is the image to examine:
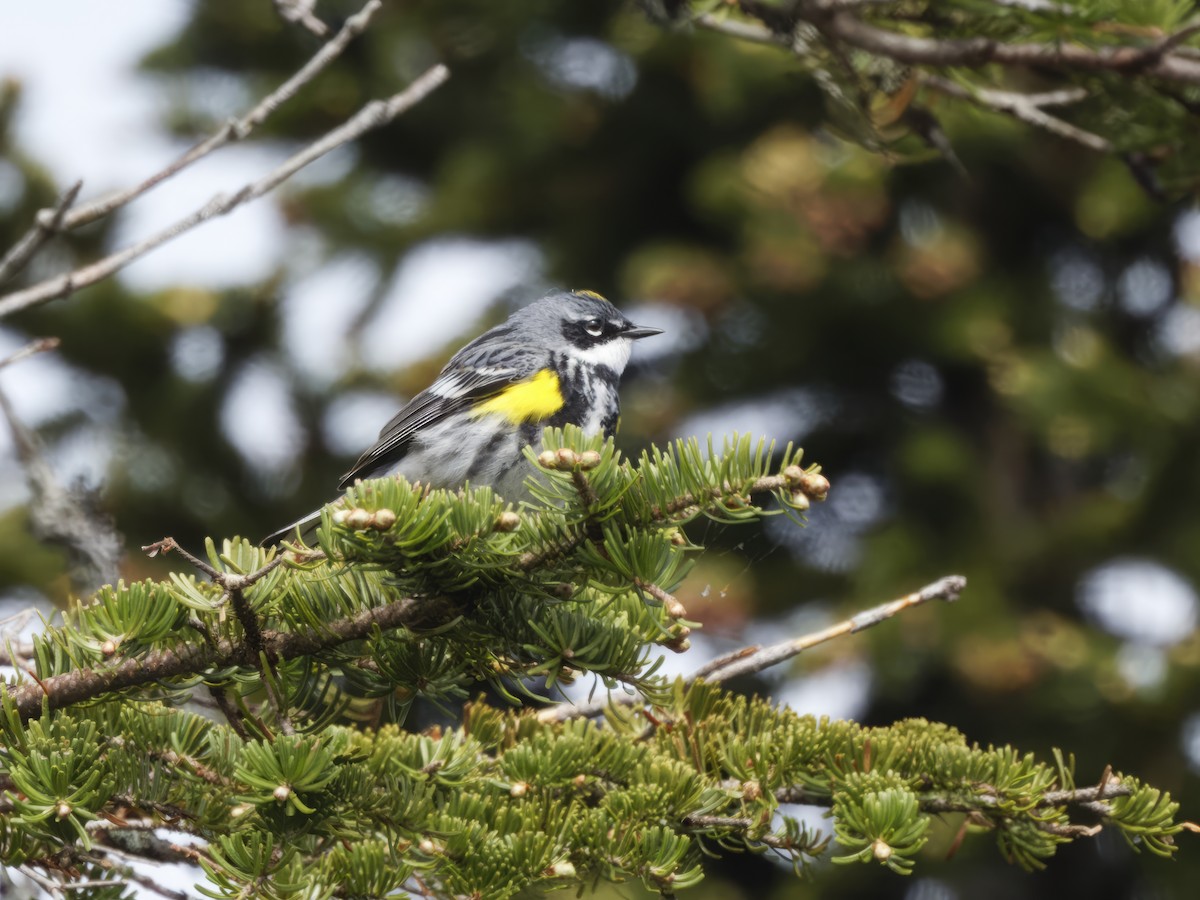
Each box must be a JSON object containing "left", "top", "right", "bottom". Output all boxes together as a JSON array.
[{"left": 338, "top": 341, "right": 538, "bottom": 488}]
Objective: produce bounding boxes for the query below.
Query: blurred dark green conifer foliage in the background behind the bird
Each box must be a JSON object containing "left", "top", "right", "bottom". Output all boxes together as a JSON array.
[{"left": 0, "top": 0, "right": 1200, "bottom": 900}]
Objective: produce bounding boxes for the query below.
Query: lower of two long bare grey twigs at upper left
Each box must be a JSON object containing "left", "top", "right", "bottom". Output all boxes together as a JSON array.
[{"left": 0, "top": 64, "right": 450, "bottom": 318}]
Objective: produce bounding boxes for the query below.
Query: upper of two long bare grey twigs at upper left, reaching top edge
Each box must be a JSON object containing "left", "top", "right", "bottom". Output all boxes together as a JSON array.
[{"left": 45, "top": 0, "right": 383, "bottom": 236}]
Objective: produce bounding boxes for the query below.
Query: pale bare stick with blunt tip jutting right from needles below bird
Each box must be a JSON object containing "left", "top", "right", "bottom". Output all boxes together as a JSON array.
[{"left": 538, "top": 575, "right": 967, "bottom": 722}]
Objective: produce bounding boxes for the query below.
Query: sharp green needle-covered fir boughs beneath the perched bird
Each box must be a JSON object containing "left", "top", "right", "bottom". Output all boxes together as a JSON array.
[{"left": 0, "top": 430, "right": 1183, "bottom": 898}]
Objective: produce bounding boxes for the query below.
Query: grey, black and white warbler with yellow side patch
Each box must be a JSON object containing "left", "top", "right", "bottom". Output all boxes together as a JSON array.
[{"left": 263, "top": 290, "right": 662, "bottom": 544}]
